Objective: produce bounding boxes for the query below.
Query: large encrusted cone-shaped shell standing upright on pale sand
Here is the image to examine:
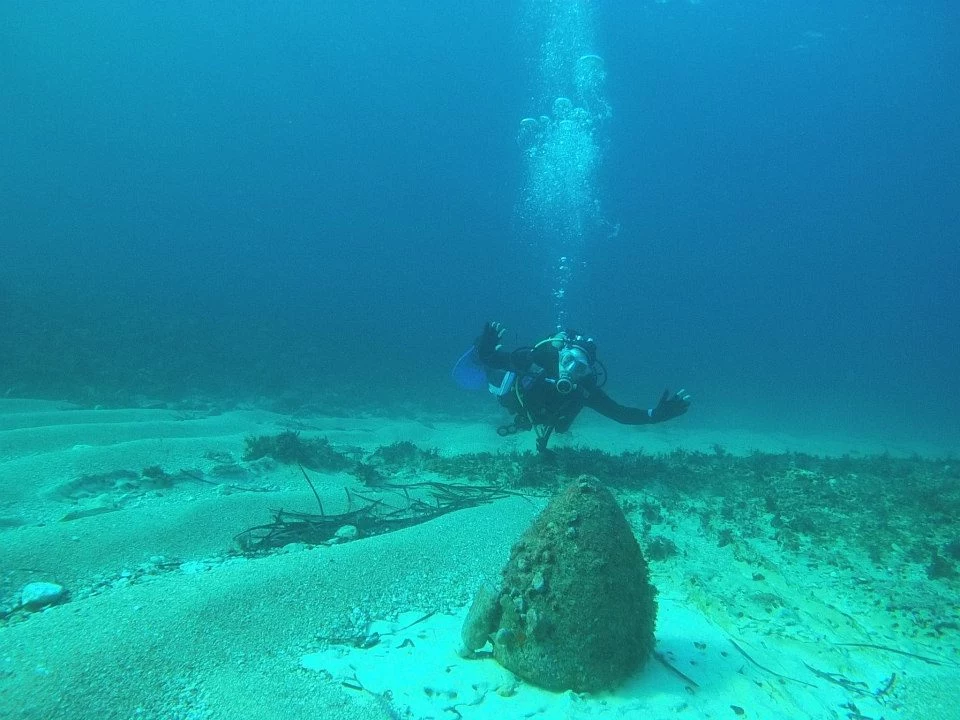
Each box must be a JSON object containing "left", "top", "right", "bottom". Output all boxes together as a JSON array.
[{"left": 463, "top": 476, "right": 657, "bottom": 692}]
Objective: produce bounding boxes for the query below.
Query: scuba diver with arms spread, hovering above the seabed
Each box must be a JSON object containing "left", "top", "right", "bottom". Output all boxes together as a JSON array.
[{"left": 455, "top": 322, "right": 690, "bottom": 453}]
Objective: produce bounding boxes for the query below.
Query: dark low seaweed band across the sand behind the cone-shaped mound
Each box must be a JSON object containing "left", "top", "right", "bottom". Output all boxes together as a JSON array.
[{"left": 231, "top": 433, "right": 960, "bottom": 626}]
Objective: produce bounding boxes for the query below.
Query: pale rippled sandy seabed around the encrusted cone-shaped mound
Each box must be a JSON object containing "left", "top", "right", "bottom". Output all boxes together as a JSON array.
[{"left": 0, "top": 400, "right": 960, "bottom": 720}]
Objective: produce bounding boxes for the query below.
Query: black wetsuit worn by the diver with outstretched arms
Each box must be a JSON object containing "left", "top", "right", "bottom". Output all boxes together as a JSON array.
[{"left": 479, "top": 343, "right": 655, "bottom": 432}]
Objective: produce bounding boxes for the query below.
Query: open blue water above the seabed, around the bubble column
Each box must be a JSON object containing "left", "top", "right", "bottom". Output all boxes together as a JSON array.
[{"left": 0, "top": 0, "right": 960, "bottom": 448}]
